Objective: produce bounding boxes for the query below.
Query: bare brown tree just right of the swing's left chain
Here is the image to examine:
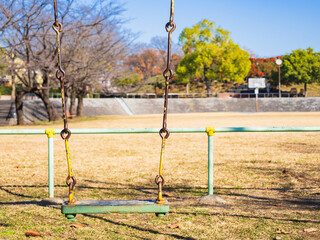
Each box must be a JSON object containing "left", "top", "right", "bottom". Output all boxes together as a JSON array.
[{"left": 64, "top": 1, "right": 135, "bottom": 116}]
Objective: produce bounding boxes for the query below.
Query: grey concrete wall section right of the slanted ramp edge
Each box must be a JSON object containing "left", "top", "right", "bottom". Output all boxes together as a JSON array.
[{"left": 124, "top": 98, "right": 320, "bottom": 114}]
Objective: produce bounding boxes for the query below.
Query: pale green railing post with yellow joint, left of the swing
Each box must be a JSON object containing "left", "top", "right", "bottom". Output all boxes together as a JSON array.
[{"left": 46, "top": 129, "right": 55, "bottom": 198}]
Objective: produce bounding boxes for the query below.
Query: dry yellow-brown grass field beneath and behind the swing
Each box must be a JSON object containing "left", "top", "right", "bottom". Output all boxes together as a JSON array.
[{"left": 0, "top": 113, "right": 320, "bottom": 239}]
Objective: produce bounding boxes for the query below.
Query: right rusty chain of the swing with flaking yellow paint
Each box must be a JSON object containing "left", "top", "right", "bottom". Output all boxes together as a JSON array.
[{"left": 155, "top": 0, "right": 176, "bottom": 204}]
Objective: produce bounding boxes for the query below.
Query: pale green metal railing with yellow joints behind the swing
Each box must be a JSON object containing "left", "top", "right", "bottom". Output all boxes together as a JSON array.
[{"left": 0, "top": 127, "right": 320, "bottom": 197}]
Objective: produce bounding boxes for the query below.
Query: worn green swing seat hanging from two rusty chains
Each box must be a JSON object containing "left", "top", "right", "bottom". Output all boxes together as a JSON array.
[{"left": 61, "top": 200, "right": 169, "bottom": 220}]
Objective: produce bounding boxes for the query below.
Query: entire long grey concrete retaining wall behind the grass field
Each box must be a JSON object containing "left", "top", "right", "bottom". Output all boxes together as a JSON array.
[{"left": 0, "top": 98, "right": 320, "bottom": 123}]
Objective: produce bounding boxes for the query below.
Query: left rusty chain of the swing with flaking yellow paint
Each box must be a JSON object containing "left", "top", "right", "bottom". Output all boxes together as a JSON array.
[{"left": 52, "top": 0, "right": 77, "bottom": 205}]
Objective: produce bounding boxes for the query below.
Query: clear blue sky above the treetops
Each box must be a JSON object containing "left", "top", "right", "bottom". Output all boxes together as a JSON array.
[{"left": 119, "top": 0, "right": 320, "bottom": 57}]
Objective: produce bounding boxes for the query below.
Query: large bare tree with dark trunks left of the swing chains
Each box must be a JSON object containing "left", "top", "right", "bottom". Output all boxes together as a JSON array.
[{"left": 0, "top": 0, "right": 59, "bottom": 124}]
